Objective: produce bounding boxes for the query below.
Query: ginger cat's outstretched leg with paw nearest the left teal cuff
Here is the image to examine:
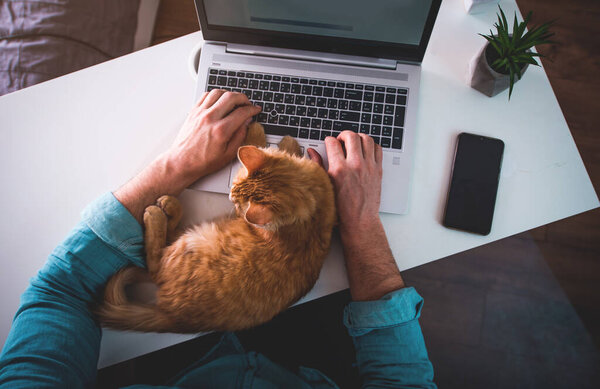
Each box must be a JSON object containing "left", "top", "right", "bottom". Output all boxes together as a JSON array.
[{"left": 144, "top": 205, "right": 167, "bottom": 279}]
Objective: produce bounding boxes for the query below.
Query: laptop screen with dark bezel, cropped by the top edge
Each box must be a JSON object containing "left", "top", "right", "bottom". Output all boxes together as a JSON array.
[{"left": 196, "top": 0, "right": 440, "bottom": 61}]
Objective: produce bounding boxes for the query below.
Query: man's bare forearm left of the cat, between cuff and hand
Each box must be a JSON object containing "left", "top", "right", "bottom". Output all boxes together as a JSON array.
[{"left": 113, "top": 155, "right": 193, "bottom": 224}]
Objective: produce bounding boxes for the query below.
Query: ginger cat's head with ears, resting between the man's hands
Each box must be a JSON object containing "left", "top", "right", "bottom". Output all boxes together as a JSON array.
[{"left": 229, "top": 146, "right": 326, "bottom": 230}]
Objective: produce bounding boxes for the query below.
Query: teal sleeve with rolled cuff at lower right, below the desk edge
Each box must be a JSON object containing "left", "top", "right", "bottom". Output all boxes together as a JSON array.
[{"left": 344, "top": 288, "right": 436, "bottom": 388}]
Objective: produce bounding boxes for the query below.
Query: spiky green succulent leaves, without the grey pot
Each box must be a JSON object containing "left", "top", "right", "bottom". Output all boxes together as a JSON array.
[{"left": 479, "top": 6, "right": 554, "bottom": 99}]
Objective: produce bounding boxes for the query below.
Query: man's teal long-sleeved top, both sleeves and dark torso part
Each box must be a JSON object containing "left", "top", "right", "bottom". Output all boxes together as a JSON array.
[{"left": 0, "top": 193, "right": 435, "bottom": 388}]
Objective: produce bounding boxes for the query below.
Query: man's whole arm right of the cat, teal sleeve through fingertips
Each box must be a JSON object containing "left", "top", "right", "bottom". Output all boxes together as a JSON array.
[{"left": 322, "top": 131, "right": 435, "bottom": 388}]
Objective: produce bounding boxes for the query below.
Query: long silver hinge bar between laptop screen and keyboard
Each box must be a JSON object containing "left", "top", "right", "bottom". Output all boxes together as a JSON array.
[{"left": 227, "top": 43, "right": 397, "bottom": 70}]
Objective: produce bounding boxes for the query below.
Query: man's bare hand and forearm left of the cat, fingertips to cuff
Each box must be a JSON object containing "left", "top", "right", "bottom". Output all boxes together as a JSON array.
[{"left": 114, "top": 89, "right": 260, "bottom": 223}]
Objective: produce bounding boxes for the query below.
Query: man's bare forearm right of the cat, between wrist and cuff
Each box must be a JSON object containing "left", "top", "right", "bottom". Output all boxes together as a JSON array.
[{"left": 340, "top": 218, "right": 404, "bottom": 301}]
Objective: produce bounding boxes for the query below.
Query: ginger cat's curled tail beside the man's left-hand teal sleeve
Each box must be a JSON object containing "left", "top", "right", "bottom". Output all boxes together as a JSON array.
[{"left": 95, "top": 266, "right": 174, "bottom": 332}]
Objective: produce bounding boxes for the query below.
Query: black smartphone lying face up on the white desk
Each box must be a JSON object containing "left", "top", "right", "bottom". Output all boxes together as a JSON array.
[{"left": 443, "top": 132, "right": 504, "bottom": 235}]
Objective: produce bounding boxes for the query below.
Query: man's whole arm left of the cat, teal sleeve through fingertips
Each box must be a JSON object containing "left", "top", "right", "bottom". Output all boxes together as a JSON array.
[{"left": 0, "top": 90, "right": 260, "bottom": 388}]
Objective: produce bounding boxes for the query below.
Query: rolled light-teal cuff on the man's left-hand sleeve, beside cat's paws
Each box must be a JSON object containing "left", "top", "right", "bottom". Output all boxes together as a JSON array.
[{"left": 81, "top": 192, "right": 146, "bottom": 267}]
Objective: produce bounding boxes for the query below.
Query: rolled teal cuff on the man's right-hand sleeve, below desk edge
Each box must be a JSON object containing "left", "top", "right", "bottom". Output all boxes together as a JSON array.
[{"left": 344, "top": 287, "right": 423, "bottom": 336}]
